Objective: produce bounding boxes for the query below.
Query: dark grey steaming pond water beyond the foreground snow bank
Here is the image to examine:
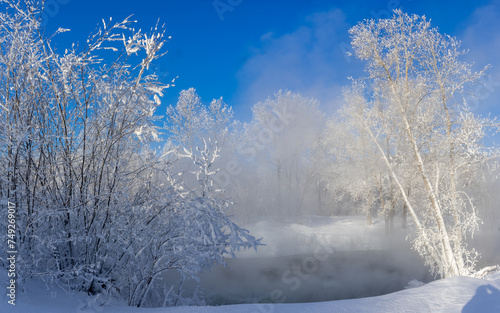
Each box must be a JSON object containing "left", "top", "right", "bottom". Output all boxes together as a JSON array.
[{"left": 201, "top": 249, "right": 433, "bottom": 305}]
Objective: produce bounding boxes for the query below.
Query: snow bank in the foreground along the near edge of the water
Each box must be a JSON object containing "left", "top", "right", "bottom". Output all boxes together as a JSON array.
[{"left": 0, "top": 272, "right": 500, "bottom": 313}]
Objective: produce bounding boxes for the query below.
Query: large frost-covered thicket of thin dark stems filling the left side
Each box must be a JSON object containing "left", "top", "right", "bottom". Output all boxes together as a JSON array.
[{"left": 0, "top": 1, "right": 259, "bottom": 306}]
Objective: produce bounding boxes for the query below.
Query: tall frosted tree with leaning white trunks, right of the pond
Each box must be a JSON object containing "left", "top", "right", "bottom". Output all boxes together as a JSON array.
[{"left": 345, "top": 10, "right": 499, "bottom": 277}]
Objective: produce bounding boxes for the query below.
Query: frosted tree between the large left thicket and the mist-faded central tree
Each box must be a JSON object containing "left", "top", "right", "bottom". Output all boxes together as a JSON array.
[{"left": 164, "top": 88, "right": 235, "bottom": 196}]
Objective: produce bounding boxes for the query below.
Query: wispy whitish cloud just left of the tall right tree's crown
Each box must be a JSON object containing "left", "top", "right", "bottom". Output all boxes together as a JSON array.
[{"left": 233, "top": 9, "right": 359, "bottom": 111}]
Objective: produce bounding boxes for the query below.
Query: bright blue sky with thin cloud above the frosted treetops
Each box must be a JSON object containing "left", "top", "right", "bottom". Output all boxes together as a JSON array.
[{"left": 45, "top": 0, "right": 500, "bottom": 121}]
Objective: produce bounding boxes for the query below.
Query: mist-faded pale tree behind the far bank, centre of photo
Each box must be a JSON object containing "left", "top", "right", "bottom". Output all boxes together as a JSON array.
[{"left": 236, "top": 91, "right": 324, "bottom": 217}]
